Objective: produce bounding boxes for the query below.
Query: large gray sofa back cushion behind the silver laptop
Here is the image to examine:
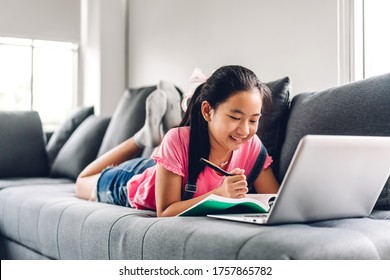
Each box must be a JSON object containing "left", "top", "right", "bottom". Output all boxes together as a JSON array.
[{"left": 278, "top": 74, "right": 390, "bottom": 209}]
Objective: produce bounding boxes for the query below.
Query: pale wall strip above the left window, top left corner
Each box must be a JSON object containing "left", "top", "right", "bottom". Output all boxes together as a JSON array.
[{"left": 0, "top": 0, "right": 80, "bottom": 43}]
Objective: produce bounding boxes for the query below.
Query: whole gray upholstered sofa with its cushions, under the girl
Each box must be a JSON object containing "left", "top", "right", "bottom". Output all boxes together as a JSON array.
[{"left": 0, "top": 74, "right": 390, "bottom": 260}]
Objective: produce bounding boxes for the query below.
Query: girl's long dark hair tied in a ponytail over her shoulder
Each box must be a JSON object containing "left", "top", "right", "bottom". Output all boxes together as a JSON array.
[{"left": 179, "top": 65, "right": 271, "bottom": 185}]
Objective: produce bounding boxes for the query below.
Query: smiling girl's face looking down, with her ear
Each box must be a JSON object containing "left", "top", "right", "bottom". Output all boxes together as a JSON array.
[{"left": 202, "top": 88, "right": 262, "bottom": 153}]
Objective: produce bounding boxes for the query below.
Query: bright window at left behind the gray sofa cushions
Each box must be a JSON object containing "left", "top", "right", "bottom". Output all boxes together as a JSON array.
[{"left": 0, "top": 37, "right": 78, "bottom": 131}]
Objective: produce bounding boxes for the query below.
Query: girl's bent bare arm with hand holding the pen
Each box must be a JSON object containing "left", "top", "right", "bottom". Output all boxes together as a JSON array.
[{"left": 156, "top": 164, "right": 248, "bottom": 217}]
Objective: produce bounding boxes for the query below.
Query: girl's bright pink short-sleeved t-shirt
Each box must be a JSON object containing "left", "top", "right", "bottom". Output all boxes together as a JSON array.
[{"left": 127, "top": 126, "right": 272, "bottom": 210}]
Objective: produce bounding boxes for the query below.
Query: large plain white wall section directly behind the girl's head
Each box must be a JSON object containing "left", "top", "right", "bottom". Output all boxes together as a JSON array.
[{"left": 128, "top": 0, "right": 339, "bottom": 94}]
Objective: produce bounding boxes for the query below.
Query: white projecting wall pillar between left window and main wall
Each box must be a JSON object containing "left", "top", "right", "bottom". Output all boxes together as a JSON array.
[{"left": 80, "top": 0, "right": 127, "bottom": 116}]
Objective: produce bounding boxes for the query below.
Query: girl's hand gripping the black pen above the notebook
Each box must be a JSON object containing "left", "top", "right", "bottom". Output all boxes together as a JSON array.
[{"left": 214, "top": 168, "right": 248, "bottom": 198}]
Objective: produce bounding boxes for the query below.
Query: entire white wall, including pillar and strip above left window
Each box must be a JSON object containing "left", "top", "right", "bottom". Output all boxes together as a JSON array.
[{"left": 0, "top": 0, "right": 348, "bottom": 115}]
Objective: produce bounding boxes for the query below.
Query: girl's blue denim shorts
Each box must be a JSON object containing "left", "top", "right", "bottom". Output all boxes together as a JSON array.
[{"left": 96, "top": 158, "right": 156, "bottom": 207}]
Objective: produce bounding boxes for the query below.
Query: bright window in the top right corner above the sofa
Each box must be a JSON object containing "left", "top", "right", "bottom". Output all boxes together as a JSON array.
[{"left": 354, "top": 0, "right": 390, "bottom": 80}]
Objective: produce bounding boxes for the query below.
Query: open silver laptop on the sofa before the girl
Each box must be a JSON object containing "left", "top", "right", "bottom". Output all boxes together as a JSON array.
[{"left": 208, "top": 135, "right": 390, "bottom": 224}]
